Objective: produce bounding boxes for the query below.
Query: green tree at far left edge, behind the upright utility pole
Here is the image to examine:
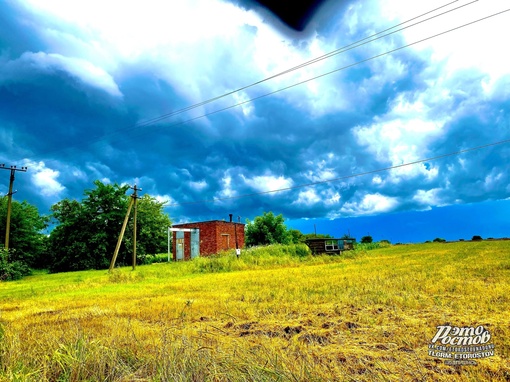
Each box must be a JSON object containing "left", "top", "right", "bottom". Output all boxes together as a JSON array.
[{"left": 0, "top": 197, "right": 49, "bottom": 268}]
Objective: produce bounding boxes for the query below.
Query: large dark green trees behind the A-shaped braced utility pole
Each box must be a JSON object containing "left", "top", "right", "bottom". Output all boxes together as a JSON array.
[{"left": 49, "top": 180, "right": 170, "bottom": 272}]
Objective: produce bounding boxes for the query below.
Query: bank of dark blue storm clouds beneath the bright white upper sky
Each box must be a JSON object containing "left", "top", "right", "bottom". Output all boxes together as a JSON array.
[{"left": 0, "top": 4, "right": 510, "bottom": 242}]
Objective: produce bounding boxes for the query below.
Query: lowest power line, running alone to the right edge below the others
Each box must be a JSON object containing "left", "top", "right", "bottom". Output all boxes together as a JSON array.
[{"left": 167, "top": 139, "right": 510, "bottom": 207}]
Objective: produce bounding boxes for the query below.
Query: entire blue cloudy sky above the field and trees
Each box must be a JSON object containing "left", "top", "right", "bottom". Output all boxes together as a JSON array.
[{"left": 0, "top": 0, "right": 510, "bottom": 242}]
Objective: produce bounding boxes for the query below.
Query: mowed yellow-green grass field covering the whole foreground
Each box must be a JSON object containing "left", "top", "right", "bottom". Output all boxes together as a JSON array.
[{"left": 0, "top": 241, "right": 510, "bottom": 381}]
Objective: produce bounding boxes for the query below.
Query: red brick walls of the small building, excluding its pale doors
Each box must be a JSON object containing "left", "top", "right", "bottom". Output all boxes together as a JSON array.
[{"left": 173, "top": 220, "right": 244, "bottom": 260}]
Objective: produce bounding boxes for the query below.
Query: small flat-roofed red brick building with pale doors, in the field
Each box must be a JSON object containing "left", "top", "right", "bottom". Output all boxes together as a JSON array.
[{"left": 171, "top": 218, "right": 244, "bottom": 260}]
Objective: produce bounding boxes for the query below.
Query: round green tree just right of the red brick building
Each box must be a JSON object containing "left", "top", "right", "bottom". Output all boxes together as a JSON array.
[{"left": 245, "top": 212, "right": 292, "bottom": 246}]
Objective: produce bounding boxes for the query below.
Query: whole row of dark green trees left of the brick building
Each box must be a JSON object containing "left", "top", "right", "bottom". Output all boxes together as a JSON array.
[{"left": 0, "top": 180, "right": 171, "bottom": 280}]
